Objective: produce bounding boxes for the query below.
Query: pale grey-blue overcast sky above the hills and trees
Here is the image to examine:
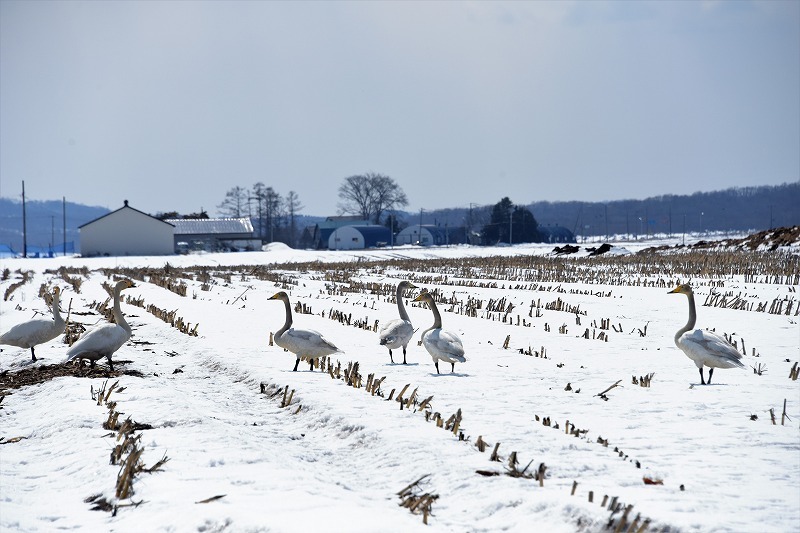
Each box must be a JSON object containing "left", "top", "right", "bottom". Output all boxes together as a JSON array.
[{"left": 0, "top": 0, "right": 800, "bottom": 216}]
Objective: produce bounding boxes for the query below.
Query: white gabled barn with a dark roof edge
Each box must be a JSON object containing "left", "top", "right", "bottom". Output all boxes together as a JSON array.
[{"left": 78, "top": 200, "right": 175, "bottom": 257}]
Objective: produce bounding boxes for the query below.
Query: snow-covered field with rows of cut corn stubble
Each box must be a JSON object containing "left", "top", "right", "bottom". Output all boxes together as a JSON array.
[{"left": 0, "top": 237, "right": 800, "bottom": 532}]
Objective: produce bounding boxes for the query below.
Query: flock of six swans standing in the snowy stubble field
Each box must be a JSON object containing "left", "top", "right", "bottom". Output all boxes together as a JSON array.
[{"left": 0, "top": 280, "right": 744, "bottom": 385}]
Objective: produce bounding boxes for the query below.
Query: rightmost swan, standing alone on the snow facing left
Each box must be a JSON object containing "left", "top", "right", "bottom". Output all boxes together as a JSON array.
[{"left": 667, "top": 283, "right": 744, "bottom": 385}]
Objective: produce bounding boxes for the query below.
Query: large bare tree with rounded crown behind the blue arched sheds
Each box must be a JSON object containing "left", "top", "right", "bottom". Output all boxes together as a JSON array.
[{"left": 339, "top": 172, "right": 408, "bottom": 224}]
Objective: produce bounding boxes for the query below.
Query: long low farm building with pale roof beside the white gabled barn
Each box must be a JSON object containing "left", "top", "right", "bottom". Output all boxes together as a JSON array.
[{"left": 166, "top": 217, "right": 261, "bottom": 253}]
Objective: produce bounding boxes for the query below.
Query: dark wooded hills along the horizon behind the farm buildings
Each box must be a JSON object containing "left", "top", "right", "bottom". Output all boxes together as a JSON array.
[{"left": 0, "top": 181, "right": 800, "bottom": 253}]
